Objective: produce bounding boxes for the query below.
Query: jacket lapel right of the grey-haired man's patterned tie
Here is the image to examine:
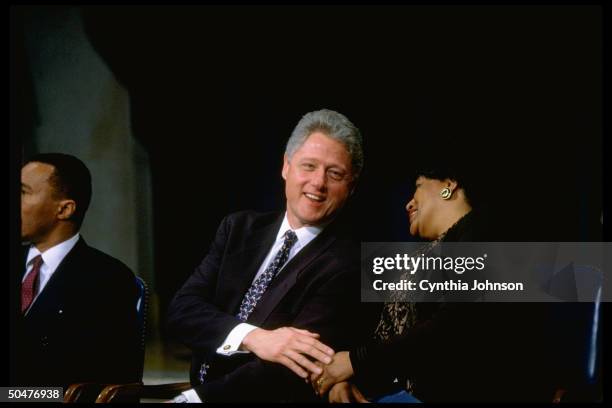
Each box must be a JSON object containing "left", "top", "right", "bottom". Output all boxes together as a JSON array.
[{"left": 249, "top": 220, "right": 336, "bottom": 325}]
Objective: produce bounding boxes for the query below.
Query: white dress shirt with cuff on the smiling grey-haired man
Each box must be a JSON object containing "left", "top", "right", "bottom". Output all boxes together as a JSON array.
[{"left": 181, "top": 212, "right": 324, "bottom": 402}]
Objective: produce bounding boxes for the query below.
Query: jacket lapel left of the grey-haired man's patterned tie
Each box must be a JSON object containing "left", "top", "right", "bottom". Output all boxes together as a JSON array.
[{"left": 222, "top": 214, "right": 284, "bottom": 313}]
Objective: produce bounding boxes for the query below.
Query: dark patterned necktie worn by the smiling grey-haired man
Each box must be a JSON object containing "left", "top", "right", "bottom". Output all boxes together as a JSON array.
[{"left": 238, "top": 230, "right": 297, "bottom": 322}]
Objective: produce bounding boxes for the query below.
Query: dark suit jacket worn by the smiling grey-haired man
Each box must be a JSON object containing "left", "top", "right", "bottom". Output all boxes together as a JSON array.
[{"left": 168, "top": 212, "right": 371, "bottom": 402}]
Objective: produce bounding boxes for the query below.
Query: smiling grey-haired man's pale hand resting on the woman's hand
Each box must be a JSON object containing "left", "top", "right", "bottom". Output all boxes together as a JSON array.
[{"left": 241, "top": 327, "right": 334, "bottom": 380}]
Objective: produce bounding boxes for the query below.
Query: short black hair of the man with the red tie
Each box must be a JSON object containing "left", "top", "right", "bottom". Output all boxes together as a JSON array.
[{"left": 24, "top": 153, "right": 91, "bottom": 227}]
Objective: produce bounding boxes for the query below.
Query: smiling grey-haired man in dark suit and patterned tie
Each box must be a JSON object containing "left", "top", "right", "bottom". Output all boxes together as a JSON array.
[{"left": 168, "top": 110, "right": 367, "bottom": 402}]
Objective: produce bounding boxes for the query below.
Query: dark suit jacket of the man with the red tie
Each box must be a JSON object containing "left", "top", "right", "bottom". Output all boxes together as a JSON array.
[{"left": 11, "top": 238, "right": 142, "bottom": 387}]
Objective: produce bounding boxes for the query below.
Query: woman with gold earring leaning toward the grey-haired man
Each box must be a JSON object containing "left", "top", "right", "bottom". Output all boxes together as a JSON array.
[{"left": 311, "top": 170, "right": 552, "bottom": 402}]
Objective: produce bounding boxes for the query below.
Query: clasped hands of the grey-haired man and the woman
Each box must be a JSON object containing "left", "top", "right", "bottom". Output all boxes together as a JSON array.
[{"left": 241, "top": 327, "right": 368, "bottom": 402}]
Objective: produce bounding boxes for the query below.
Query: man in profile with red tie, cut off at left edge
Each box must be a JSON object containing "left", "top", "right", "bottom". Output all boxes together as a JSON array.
[{"left": 11, "top": 153, "right": 141, "bottom": 388}]
